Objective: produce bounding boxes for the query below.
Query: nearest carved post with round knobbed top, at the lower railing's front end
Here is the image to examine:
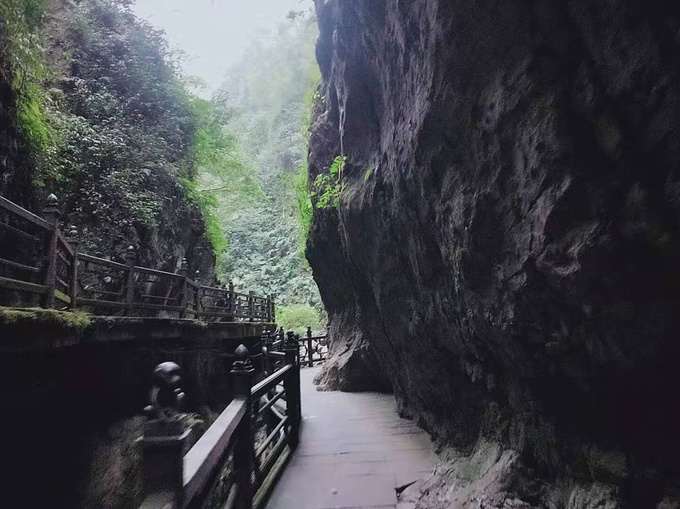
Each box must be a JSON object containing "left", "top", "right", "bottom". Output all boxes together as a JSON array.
[{"left": 139, "top": 362, "right": 191, "bottom": 507}]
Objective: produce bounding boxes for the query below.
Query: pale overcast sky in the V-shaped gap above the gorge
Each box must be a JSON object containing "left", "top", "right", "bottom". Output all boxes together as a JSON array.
[{"left": 134, "top": 0, "right": 312, "bottom": 89}]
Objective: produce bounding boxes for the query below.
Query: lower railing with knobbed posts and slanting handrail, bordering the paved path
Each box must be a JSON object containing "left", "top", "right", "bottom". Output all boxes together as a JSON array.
[{"left": 140, "top": 333, "right": 302, "bottom": 509}]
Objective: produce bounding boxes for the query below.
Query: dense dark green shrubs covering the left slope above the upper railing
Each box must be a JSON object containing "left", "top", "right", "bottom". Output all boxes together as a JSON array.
[{"left": 0, "top": 0, "right": 260, "bottom": 262}]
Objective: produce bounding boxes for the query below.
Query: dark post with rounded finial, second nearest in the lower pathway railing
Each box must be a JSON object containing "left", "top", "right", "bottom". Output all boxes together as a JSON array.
[{"left": 231, "top": 345, "right": 255, "bottom": 509}]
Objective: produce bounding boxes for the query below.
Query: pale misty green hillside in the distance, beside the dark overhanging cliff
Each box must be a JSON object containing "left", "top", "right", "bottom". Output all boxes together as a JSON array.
[{"left": 211, "top": 12, "right": 322, "bottom": 311}]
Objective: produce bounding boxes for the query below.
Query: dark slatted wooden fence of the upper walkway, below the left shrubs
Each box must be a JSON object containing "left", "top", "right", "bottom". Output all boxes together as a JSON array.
[{"left": 0, "top": 195, "right": 275, "bottom": 323}]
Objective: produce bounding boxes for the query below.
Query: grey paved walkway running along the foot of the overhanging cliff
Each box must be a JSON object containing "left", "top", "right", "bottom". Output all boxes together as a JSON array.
[{"left": 267, "top": 368, "right": 436, "bottom": 509}]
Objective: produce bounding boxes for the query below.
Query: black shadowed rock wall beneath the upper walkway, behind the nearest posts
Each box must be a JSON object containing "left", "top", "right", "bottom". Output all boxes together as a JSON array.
[{"left": 0, "top": 315, "right": 270, "bottom": 509}]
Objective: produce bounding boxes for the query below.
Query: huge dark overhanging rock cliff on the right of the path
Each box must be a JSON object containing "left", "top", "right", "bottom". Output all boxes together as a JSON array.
[{"left": 307, "top": 0, "right": 680, "bottom": 508}]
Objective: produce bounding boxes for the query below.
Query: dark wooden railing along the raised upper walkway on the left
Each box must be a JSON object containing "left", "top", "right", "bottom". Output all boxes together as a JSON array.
[{"left": 0, "top": 195, "right": 275, "bottom": 323}]
